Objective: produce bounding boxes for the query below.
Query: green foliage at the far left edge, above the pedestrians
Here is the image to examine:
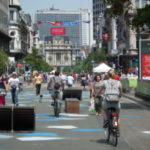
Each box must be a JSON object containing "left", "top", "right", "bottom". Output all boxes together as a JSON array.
[{"left": 0, "top": 48, "right": 8, "bottom": 73}]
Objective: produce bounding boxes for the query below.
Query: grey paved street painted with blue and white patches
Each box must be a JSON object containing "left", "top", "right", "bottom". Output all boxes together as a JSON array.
[{"left": 0, "top": 84, "right": 150, "bottom": 150}]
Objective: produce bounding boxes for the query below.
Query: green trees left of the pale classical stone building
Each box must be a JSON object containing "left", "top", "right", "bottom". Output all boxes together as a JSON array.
[{"left": 23, "top": 49, "right": 52, "bottom": 71}]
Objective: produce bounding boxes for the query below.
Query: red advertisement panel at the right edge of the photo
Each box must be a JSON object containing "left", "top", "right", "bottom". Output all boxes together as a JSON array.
[{"left": 142, "top": 54, "right": 150, "bottom": 80}]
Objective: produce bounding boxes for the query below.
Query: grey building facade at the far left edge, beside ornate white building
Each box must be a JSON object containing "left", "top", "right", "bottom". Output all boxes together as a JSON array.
[{"left": 0, "top": 0, "right": 10, "bottom": 52}]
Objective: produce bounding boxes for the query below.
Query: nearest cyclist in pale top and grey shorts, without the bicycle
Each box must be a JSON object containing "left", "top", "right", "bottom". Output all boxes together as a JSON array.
[{"left": 100, "top": 70, "right": 122, "bottom": 128}]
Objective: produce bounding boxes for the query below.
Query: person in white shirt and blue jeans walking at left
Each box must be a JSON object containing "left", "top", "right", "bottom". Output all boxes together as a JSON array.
[{"left": 8, "top": 72, "right": 20, "bottom": 106}]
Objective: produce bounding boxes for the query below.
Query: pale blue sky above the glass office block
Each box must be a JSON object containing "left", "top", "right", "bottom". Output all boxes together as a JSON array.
[{"left": 20, "top": 0, "right": 92, "bottom": 14}]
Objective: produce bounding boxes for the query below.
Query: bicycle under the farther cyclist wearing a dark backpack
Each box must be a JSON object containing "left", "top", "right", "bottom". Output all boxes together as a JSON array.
[{"left": 52, "top": 90, "right": 61, "bottom": 117}]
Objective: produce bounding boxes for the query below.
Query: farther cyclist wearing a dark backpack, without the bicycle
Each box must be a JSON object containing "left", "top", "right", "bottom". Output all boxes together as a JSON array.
[{"left": 47, "top": 71, "right": 64, "bottom": 104}]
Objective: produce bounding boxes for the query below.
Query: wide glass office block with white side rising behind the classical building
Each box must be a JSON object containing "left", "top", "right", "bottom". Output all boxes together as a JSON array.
[{"left": 35, "top": 8, "right": 92, "bottom": 47}]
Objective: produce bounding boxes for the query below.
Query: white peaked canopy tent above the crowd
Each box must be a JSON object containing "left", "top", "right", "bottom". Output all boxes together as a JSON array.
[{"left": 93, "top": 63, "right": 112, "bottom": 73}]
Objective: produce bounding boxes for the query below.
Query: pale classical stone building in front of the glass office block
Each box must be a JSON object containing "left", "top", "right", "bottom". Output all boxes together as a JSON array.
[{"left": 45, "top": 36, "right": 75, "bottom": 69}]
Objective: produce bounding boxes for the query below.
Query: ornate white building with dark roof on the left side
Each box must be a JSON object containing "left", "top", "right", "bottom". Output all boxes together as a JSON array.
[{"left": 9, "top": 0, "right": 32, "bottom": 61}]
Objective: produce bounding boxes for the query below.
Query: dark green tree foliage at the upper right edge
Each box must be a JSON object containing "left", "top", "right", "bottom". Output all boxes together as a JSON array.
[{"left": 132, "top": 5, "right": 150, "bottom": 27}]
